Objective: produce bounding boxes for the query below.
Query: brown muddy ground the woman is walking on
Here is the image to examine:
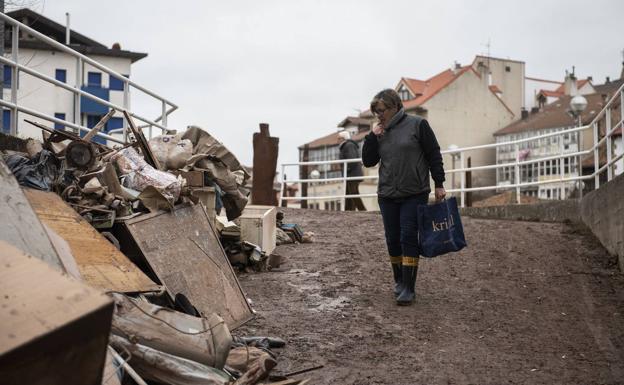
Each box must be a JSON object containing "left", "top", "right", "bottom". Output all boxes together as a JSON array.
[{"left": 236, "top": 209, "right": 624, "bottom": 385}]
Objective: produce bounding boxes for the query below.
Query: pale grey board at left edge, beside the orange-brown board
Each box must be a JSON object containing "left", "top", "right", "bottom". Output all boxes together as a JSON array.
[{"left": 0, "top": 156, "right": 63, "bottom": 271}]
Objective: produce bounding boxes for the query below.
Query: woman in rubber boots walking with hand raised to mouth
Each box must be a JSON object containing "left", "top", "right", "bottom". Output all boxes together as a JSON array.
[{"left": 362, "top": 89, "right": 446, "bottom": 305}]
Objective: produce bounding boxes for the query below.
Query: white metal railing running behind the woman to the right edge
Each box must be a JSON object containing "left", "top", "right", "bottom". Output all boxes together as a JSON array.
[{"left": 279, "top": 80, "right": 624, "bottom": 210}]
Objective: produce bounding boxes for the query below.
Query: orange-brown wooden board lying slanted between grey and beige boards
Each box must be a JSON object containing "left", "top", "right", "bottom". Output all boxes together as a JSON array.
[{"left": 24, "top": 189, "right": 160, "bottom": 293}]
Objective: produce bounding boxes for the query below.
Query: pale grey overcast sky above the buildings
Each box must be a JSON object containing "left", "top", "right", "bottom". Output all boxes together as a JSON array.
[{"left": 12, "top": 0, "right": 624, "bottom": 170}]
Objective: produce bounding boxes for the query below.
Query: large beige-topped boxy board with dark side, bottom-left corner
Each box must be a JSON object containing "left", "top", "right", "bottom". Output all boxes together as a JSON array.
[{"left": 0, "top": 241, "right": 113, "bottom": 385}]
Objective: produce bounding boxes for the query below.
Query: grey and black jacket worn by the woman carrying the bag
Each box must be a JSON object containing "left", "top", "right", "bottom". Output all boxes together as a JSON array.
[{"left": 362, "top": 110, "right": 445, "bottom": 198}]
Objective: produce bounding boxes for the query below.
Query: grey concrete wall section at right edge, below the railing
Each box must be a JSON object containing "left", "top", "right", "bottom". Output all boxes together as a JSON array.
[{"left": 580, "top": 175, "right": 624, "bottom": 271}]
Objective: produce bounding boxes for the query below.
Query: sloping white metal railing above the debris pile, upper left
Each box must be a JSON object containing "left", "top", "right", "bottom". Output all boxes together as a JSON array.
[{"left": 0, "top": 13, "right": 178, "bottom": 143}]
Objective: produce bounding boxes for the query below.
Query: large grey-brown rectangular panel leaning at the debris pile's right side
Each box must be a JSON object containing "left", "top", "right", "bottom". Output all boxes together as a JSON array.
[{"left": 125, "top": 205, "right": 252, "bottom": 329}]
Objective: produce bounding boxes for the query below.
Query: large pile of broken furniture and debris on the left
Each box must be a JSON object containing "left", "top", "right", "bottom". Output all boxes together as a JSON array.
[{"left": 0, "top": 112, "right": 311, "bottom": 385}]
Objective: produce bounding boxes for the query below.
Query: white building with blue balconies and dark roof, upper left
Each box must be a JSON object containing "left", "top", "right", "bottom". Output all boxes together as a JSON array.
[{"left": 1, "top": 9, "right": 147, "bottom": 141}]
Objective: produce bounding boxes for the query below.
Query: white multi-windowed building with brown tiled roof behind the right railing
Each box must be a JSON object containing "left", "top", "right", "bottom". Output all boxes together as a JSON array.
[{"left": 494, "top": 71, "right": 622, "bottom": 199}]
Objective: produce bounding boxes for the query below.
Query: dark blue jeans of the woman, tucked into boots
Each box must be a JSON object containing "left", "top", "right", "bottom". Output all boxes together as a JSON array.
[{"left": 378, "top": 193, "right": 429, "bottom": 257}]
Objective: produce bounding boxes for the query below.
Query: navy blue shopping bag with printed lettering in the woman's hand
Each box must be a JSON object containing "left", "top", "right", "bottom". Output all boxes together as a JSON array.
[{"left": 417, "top": 198, "right": 466, "bottom": 257}]
